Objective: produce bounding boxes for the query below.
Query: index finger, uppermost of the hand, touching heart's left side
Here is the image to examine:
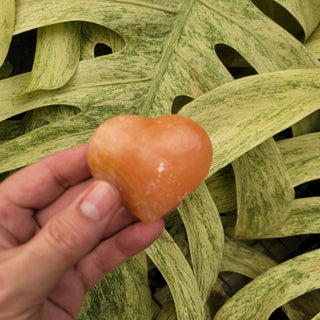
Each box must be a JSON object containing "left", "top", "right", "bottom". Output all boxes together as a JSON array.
[{"left": 0, "top": 144, "right": 91, "bottom": 209}]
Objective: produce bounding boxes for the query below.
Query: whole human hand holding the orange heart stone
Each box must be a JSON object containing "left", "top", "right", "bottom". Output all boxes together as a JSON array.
[{"left": 0, "top": 145, "right": 164, "bottom": 320}]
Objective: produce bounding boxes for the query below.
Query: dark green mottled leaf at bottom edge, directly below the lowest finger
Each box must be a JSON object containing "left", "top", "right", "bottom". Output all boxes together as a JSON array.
[{"left": 78, "top": 253, "right": 152, "bottom": 320}]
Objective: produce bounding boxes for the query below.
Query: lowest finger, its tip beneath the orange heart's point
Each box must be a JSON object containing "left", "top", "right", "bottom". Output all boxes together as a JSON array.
[{"left": 77, "top": 220, "right": 164, "bottom": 290}]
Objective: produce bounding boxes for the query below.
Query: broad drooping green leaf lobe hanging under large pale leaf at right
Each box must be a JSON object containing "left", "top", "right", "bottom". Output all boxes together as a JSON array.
[{"left": 232, "top": 139, "right": 294, "bottom": 239}]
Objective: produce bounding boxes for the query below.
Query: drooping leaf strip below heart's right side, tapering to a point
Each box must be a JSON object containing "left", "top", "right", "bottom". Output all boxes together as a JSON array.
[{"left": 179, "top": 183, "right": 224, "bottom": 303}]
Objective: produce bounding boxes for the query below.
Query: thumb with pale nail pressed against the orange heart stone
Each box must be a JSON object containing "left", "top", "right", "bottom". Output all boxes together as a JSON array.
[{"left": 22, "top": 181, "right": 120, "bottom": 294}]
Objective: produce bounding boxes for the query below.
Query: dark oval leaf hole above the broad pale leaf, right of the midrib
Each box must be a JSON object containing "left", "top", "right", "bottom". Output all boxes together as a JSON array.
[{"left": 215, "top": 43, "right": 257, "bottom": 79}]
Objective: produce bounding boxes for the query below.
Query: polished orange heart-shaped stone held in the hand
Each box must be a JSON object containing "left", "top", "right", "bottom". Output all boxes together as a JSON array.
[{"left": 88, "top": 115, "right": 212, "bottom": 223}]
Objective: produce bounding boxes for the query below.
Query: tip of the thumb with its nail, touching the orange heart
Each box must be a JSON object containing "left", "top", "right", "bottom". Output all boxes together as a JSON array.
[{"left": 80, "top": 181, "right": 118, "bottom": 221}]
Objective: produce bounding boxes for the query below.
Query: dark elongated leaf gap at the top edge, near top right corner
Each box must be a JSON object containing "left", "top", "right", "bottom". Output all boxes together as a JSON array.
[{"left": 251, "top": 0, "right": 305, "bottom": 41}]
